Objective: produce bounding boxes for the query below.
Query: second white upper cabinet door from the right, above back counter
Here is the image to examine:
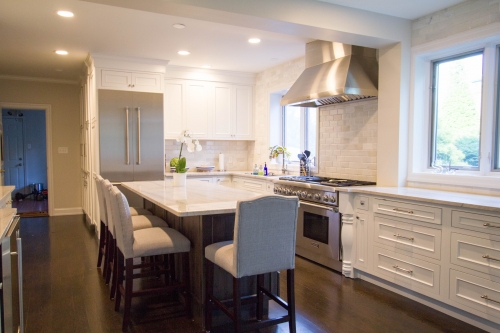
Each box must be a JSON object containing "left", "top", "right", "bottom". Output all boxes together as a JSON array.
[{"left": 213, "top": 84, "right": 233, "bottom": 138}]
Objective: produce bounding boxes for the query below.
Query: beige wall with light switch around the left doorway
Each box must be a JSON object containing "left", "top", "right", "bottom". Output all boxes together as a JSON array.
[{"left": 0, "top": 79, "right": 82, "bottom": 211}]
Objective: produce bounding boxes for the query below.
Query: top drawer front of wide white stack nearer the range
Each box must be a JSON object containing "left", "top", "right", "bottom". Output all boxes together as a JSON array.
[{"left": 373, "top": 199, "right": 442, "bottom": 224}]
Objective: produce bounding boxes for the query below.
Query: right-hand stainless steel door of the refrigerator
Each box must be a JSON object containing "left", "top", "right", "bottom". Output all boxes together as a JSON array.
[{"left": 131, "top": 92, "right": 165, "bottom": 180}]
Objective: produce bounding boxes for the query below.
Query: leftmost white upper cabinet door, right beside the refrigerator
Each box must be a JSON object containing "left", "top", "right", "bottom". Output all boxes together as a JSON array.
[{"left": 164, "top": 80, "right": 185, "bottom": 139}]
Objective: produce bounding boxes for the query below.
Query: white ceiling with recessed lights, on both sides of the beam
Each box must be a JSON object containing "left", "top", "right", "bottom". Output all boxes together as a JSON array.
[{"left": 0, "top": 0, "right": 460, "bottom": 81}]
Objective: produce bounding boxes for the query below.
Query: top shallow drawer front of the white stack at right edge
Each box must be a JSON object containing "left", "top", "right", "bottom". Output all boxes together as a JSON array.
[{"left": 451, "top": 210, "right": 500, "bottom": 235}]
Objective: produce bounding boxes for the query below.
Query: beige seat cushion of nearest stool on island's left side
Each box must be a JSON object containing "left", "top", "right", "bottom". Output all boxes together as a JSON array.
[{"left": 133, "top": 228, "right": 191, "bottom": 258}]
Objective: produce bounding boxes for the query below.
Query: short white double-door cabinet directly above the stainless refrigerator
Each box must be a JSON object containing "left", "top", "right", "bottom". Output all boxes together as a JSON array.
[{"left": 98, "top": 69, "right": 163, "bottom": 92}]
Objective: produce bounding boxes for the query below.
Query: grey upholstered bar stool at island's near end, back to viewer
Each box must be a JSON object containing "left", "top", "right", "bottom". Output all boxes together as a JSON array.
[{"left": 205, "top": 196, "right": 298, "bottom": 333}]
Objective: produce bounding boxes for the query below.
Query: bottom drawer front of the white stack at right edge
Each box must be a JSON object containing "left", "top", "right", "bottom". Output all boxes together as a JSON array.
[{"left": 450, "top": 269, "right": 500, "bottom": 322}]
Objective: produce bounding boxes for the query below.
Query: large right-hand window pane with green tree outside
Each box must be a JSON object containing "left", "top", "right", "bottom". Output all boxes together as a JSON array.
[{"left": 430, "top": 51, "right": 483, "bottom": 170}]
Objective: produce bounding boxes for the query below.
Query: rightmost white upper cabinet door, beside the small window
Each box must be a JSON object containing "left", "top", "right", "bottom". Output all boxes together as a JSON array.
[{"left": 233, "top": 86, "right": 253, "bottom": 139}]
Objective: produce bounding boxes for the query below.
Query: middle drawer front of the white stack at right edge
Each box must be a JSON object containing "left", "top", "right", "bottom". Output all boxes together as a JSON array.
[{"left": 451, "top": 232, "right": 500, "bottom": 276}]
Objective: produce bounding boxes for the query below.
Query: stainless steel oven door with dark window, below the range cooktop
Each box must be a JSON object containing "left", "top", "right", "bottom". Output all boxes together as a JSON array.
[{"left": 296, "top": 201, "right": 342, "bottom": 271}]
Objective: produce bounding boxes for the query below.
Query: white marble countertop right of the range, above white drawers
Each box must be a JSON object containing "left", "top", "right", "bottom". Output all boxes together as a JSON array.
[{"left": 335, "top": 186, "right": 500, "bottom": 212}]
